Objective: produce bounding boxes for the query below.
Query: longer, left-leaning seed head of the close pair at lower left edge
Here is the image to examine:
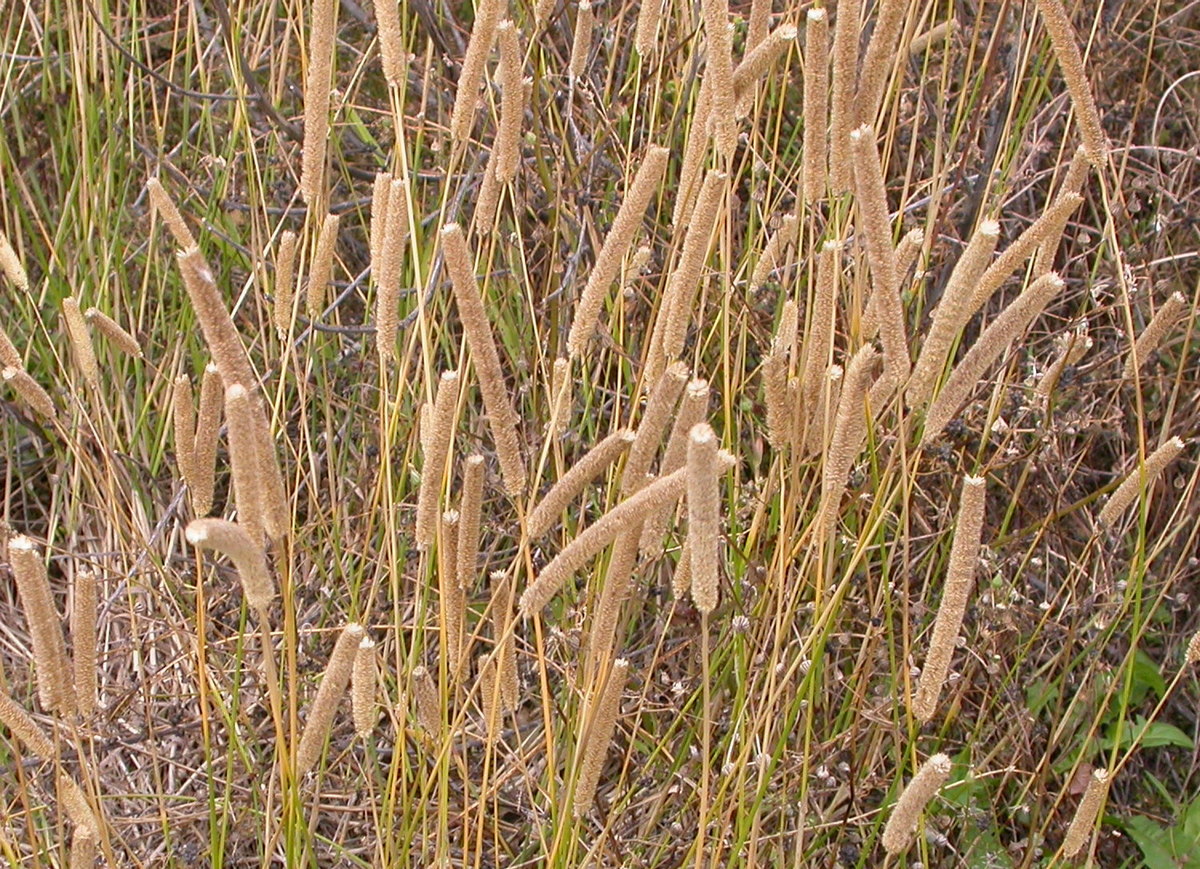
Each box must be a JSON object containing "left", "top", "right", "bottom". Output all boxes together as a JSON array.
[{"left": 8, "top": 537, "right": 76, "bottom": 715}]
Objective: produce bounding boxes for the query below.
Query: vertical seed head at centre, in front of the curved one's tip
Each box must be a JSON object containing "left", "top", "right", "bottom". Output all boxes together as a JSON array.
[{"left": 688, "top": 422, "right": 721, "bottom": 616}]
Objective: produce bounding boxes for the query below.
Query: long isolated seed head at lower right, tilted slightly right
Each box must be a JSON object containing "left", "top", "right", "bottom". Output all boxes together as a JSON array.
[{"left": 912, "top": 477, "right": 986, "bottom": 724}]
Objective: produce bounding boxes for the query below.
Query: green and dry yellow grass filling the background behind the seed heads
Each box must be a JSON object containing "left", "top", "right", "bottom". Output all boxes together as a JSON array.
[{"left": 0, "top": 0, "right": 1200, "bottom": 867}]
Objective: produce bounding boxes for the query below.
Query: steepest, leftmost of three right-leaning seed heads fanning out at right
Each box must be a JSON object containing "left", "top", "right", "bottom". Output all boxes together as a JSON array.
[{"left": 905, "top": 221, "right": 1000, "bottom": 407}]
